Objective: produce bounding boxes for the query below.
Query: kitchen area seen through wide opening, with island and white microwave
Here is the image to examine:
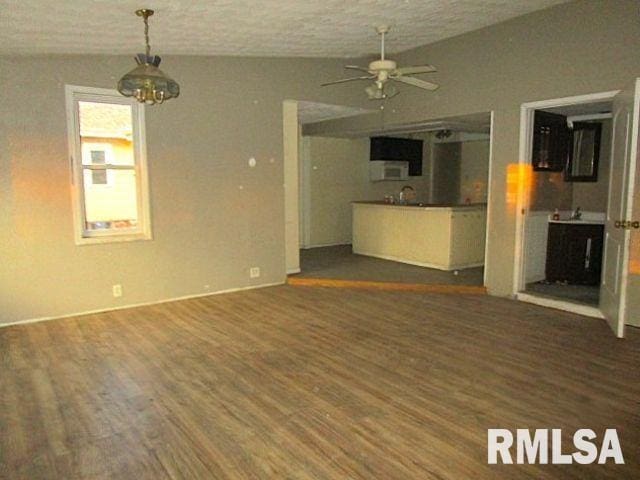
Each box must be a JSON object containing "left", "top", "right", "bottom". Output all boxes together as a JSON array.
[{"left": 296, "top": 114, "right": 490, "bottom": 286}]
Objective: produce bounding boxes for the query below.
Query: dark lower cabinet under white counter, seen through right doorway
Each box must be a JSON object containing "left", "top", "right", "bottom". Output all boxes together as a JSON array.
[{"left": 546, "top": 223, "right": 604, "bottom": 285}]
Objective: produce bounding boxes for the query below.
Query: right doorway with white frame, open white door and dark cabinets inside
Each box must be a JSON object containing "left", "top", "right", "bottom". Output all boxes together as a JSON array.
[{"left": 514, "top": 82, "right": 638, "bottom": 337}]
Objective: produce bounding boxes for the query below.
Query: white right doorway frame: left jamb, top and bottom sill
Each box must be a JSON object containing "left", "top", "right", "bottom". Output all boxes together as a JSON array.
[{"left": 513, "top": 90, "right": 620, "bottom": 318}]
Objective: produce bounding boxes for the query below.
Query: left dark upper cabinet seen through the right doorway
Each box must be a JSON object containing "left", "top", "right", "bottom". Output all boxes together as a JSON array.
[{"left": 531, "top": 110, "right": 569, "bottom": 172}]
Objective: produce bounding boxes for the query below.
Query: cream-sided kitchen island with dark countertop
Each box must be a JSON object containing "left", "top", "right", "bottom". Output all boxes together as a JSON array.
[{"left": 352, "top": 202, "right": 487, "bottom": 270}]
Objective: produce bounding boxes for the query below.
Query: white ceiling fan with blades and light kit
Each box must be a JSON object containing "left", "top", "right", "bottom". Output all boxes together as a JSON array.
[{"left": 322, "top": 25, "right": 438, "bottom": 100}]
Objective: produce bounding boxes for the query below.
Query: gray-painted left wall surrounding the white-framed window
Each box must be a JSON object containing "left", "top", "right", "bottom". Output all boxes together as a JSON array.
[{"left": 0, "top": 56, "right": 365, "bottom": 323}]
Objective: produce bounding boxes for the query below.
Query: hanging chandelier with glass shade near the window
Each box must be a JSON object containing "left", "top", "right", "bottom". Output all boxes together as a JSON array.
[{"left": 118, "top": 9, "right": 180, "bottom": 105}]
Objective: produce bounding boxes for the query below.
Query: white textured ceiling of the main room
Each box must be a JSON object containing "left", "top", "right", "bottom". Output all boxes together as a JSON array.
[{"left": 0, "top": 0, "right": 566, "bottom": 57}]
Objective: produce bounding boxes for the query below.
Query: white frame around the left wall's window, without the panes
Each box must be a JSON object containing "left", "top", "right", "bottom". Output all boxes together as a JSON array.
[{"left": 65, "top": 85, "right": 152, "bottom": 245}]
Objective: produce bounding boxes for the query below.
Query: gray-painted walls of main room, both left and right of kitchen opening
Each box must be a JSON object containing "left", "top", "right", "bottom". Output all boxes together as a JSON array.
[{"left": 0, "top": 0, "right": 640, "bottom": 322}]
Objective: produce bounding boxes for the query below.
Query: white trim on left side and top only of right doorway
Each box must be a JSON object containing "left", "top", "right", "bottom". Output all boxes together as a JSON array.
[{"left": 512, "top": 90, "right": 619, "bottom": 297}]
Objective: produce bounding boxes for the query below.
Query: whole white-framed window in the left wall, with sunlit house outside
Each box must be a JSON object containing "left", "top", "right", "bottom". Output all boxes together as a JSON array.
[{"left": 66, "top": 85, "right": 151, "bottom": 244}]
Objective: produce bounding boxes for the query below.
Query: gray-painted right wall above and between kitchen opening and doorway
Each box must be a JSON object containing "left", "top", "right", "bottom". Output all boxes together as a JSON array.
[{"left": 294, "top": 0, "right": 640, "bottom": 311}]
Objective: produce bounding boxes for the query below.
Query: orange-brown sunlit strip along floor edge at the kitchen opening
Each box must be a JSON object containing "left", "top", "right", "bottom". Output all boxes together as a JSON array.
[{"left": 287, "top": 277, "right": 487, "bottom": 295}]
